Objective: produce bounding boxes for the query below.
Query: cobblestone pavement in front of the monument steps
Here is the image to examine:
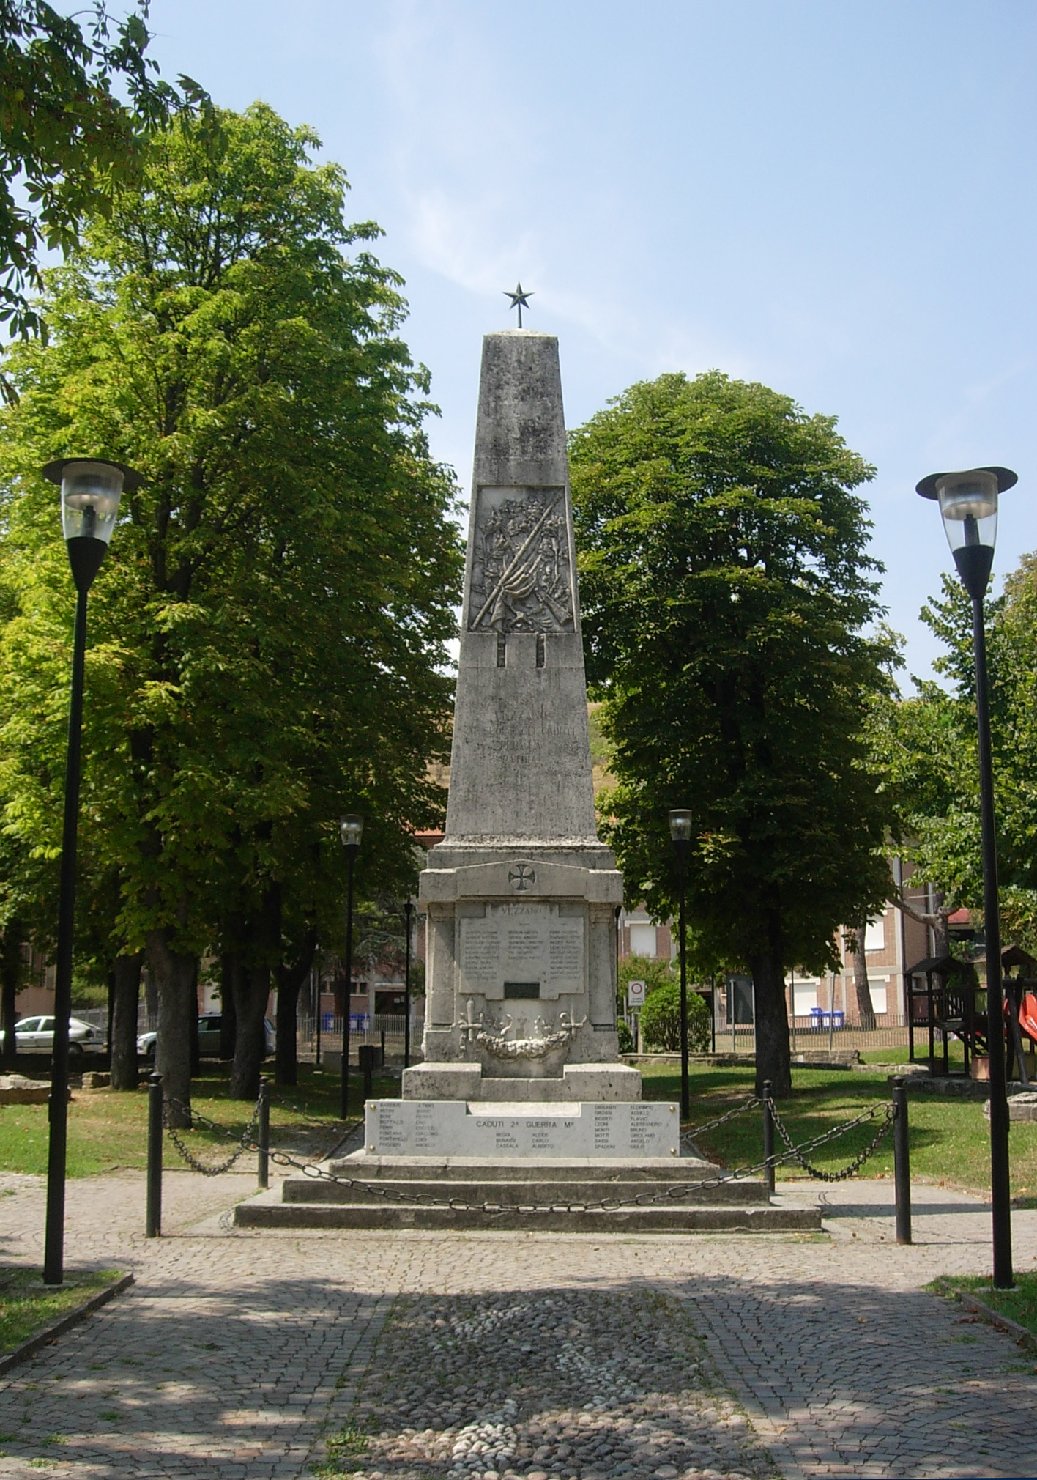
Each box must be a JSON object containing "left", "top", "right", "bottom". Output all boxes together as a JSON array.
[{"left": 0, "top": 1172, "right": 1037, "bottom": 1480}]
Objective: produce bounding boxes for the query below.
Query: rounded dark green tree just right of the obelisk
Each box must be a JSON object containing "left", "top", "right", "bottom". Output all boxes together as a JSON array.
[{"left": 571, "top": 371, "right": 889, "bottom": 1094}]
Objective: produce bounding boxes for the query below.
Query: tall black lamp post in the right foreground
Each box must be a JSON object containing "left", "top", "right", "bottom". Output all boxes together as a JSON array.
[{"left": 917, "top": 468, "right": 1016, "bottom": 1289}]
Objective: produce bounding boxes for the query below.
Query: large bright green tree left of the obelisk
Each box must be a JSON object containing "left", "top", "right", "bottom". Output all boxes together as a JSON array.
[{"left": 0, "top": 105, "right": 460, "bottom": 1103}]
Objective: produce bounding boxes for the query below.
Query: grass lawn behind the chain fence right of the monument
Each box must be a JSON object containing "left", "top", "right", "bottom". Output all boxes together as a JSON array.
[{"left": 644, "top": 1064, "right": 1037, "bottom": 1206}]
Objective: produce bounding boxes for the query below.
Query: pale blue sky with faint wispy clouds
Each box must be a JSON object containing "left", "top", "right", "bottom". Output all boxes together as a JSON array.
[{"left": 141, "top": 0, "right": 1037, "bottom": 676}]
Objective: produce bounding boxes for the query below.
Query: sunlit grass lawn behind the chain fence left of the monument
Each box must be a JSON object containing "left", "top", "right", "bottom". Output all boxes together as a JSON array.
[{"left": 0, "top": 1064, "right": 399, "bottom": 1177}]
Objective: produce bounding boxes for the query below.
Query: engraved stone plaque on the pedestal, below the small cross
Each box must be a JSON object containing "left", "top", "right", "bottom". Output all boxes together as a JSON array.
[{"left": 457, "top": 904, "right": 584, "bottom": 999}]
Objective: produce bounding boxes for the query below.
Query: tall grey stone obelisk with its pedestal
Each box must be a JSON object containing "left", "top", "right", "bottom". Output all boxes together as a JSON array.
[{"left": 404, "top": 329, "right": 641, "bottom": 1104}]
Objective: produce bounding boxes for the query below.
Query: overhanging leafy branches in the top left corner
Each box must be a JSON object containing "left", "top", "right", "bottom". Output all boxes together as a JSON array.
[{"left": 0, "top": 0, "right": 207, "bottom": 334}]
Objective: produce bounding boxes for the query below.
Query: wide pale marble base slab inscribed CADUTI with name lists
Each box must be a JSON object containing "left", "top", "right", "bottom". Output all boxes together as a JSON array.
[{"left": 364, "top": 1100, "right": 680, "bottom": 1160}]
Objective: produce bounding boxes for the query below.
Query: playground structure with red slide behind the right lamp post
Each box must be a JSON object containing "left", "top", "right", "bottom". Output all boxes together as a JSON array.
[{"left": 905, "top": 946, "right": 1037, "bottom": 1085}]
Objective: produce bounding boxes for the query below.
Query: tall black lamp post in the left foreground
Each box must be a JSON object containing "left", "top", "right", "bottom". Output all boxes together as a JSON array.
[{"left": 43, "top": 457, "right": 141, "bottom": 1285}]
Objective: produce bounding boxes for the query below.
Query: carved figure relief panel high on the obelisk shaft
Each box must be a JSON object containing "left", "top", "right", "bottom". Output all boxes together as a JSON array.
[{"left": 467, "top": 487, "right": 575, "bottom": 632}]
